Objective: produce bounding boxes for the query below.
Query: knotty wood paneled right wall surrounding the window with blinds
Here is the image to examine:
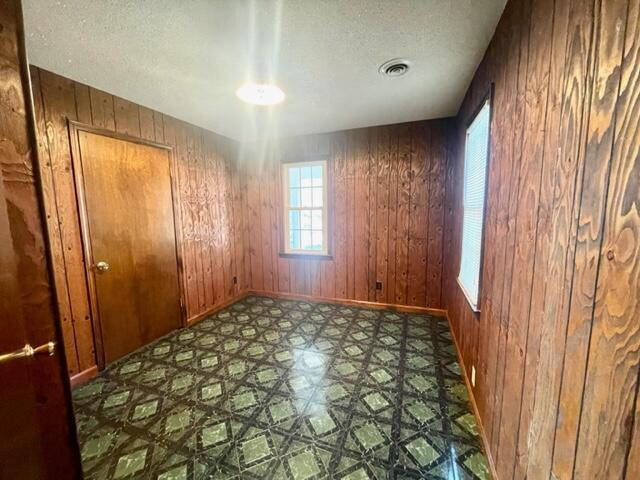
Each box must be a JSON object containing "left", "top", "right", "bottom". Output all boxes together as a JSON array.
[{"left": 443, "top": 0, "right": 640, "bottom": 479}]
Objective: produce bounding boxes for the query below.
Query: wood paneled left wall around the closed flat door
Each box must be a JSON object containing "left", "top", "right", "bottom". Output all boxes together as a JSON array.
[{"left": 31, "top": 67, "right": 248, "bottom": 375}]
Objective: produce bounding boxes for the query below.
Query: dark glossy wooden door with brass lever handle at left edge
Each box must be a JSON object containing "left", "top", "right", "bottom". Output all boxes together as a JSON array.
[{"left": 0, "top": 0, "right": 81, "bottom": 480}]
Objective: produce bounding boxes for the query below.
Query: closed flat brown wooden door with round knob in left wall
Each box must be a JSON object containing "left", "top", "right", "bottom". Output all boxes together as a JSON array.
[{"left": 72, "top": 126, "right": 181, "bottom": 363}]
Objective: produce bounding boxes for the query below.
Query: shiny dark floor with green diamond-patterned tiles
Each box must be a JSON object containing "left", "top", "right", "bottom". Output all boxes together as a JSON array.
[{"left": 73, "top": 296, "right": 489, "bottom": 480}]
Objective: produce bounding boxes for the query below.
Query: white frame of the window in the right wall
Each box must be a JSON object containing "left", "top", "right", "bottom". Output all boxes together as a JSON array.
[{"left": 457, "top": 98, "right": 491, "bottom": 312}]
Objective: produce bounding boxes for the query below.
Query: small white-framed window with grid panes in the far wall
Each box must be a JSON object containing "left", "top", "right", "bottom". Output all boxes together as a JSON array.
[{"left": 282, "top": 160, "right": 329, "bottom": 255}]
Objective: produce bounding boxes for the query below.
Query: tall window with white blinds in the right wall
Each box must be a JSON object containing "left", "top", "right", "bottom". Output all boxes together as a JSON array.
[{"left": 458, "top": 100, "right": 490, "bottom": 311}]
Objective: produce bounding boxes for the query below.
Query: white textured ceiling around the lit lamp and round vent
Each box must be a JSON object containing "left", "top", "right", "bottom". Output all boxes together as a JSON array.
[{"left": 23, "top": 0, "right": 505, "bottom": 140}]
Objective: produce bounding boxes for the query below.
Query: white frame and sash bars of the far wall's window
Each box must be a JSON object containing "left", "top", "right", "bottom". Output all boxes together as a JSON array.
[{"left": 282, "top": 160, "right": 329, "bottom": 256}]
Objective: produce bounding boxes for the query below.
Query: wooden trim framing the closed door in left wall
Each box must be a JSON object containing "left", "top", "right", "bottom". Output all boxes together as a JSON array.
[{"left": 67, "top": 118, "right": 187, "bottom": 370}]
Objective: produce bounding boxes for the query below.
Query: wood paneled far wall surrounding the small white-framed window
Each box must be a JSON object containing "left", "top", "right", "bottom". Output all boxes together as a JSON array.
[{"left": 240, "top": 120, "right": 451, "bottom": 308}]
